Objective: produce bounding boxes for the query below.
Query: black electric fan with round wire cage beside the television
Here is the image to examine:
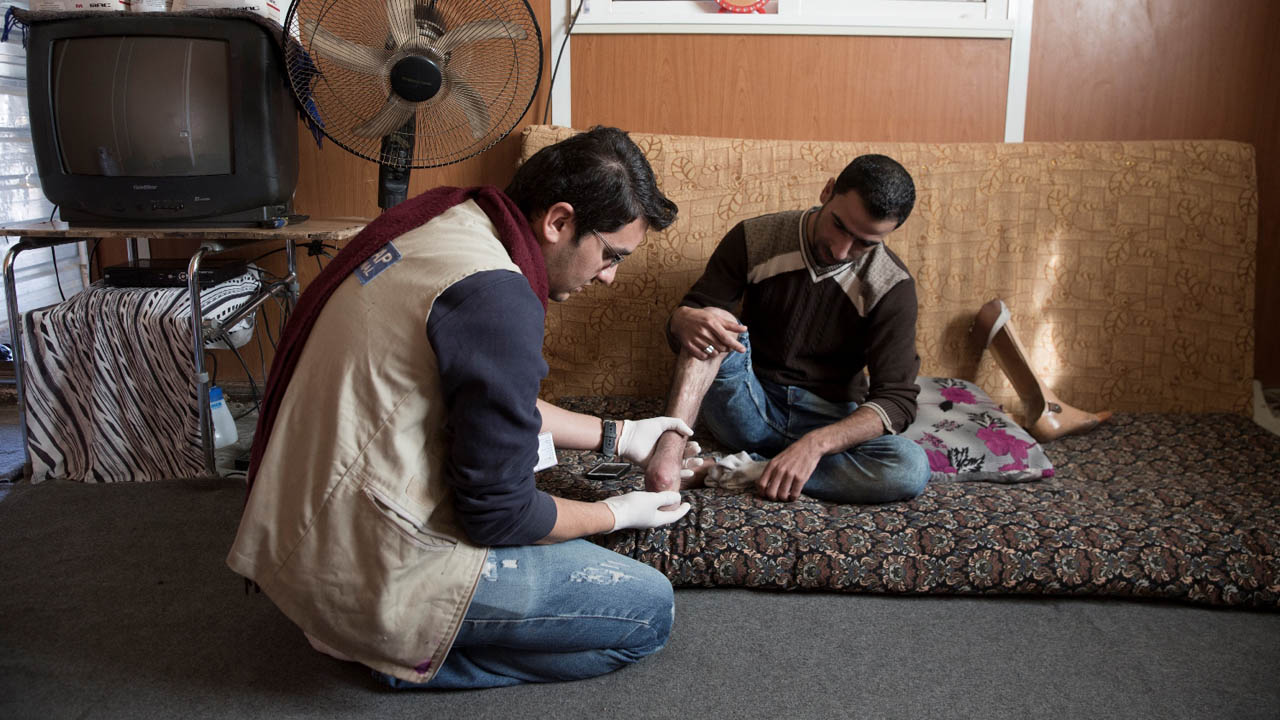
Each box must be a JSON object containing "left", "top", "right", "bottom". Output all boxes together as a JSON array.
[{"left": 284, "top": 0, "right": 543, "bottom": 210}]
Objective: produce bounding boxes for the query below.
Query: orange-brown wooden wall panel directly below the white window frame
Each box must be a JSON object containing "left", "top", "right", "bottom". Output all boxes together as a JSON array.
[{"left": 572, "top": 35, "right": 1009, "bottom": 142}]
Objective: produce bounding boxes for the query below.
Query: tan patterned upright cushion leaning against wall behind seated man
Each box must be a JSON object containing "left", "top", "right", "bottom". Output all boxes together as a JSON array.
[{"left": 522, "top": 126, "right": 1258, "bottom": 420}]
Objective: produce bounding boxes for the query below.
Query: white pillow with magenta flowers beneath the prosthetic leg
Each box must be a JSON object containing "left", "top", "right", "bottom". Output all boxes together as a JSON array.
[{"left": 902, "top": 377, "right": 1053, "bottom": 483}]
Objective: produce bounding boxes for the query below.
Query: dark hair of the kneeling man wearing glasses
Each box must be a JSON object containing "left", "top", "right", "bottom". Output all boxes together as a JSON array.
[{"left": 507, "top": 126, "right": 678, "bottom": 238}]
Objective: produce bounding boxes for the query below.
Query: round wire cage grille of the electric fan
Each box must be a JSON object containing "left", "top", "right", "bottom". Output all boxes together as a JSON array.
[{"left": 284, "top": 0, "right": 543, "bottom": 168}]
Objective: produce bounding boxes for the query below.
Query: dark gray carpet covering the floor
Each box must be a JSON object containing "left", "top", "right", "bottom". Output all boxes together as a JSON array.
[{"left": 0, "top": 471, "right": 1280, "bottom": 720}]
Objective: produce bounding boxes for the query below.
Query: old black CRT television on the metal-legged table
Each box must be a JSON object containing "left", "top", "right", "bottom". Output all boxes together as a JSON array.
[{"left": 27, "top": 13, "right": 298, "bottom": 225}]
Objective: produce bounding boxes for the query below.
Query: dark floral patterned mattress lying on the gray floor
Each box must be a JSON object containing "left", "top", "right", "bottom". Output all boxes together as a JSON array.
[{"left": 538, "top": 398, "right": 1280, "bottom": 610}]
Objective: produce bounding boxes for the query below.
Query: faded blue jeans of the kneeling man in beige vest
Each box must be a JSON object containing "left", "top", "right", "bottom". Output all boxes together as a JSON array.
[{"left": 374, "top": 539, "right": 676, "bottom": 689}]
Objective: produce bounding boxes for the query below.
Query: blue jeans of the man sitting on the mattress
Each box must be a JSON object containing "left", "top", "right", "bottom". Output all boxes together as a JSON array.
[{"left": 701, "top": 333, "right": 929, "bottom": 503}]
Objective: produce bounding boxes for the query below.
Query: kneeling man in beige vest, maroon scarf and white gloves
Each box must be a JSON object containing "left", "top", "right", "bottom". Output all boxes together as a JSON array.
[{"left": 228, "top": 128, "right": 691, "bottom": 688}]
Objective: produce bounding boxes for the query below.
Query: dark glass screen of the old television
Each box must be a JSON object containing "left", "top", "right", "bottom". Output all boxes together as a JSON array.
[{"left": 52, "top": 37, "right": 232, "bottom": 177}]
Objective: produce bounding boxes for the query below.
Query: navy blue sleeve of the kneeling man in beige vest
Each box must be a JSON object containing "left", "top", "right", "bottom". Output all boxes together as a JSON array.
[{"left": 426, "top": 270, "right": 556, "bottom": 546}]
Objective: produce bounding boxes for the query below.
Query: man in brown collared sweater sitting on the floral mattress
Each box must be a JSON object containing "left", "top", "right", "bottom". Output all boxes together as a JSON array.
[{"left": 645, "top": 155, "right": 929, "bottom": 503}]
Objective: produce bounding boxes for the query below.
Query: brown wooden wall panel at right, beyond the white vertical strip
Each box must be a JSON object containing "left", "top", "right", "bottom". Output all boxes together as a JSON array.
[{"left": 1027, "top": 0, "right": 1280, "bottom": 386}]
